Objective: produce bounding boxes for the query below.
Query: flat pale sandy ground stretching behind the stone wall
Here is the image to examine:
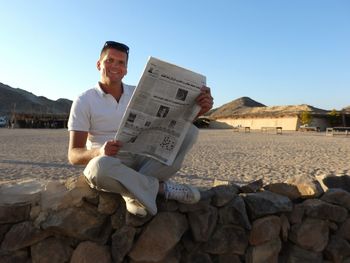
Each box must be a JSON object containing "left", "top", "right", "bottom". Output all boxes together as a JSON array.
[{"left": 0, "top": 128, "right": 350, "bottom": 188}]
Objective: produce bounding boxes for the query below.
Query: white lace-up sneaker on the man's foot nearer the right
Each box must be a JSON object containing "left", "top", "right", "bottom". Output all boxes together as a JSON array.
[{"left": 164, "top": 181, "right": 201, "bottom": 204}]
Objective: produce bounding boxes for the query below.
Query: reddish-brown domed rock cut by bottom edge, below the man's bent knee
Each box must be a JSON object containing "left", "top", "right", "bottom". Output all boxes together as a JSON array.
[{"left": 70, "top": 241, "right": 112, "bottom": 263}]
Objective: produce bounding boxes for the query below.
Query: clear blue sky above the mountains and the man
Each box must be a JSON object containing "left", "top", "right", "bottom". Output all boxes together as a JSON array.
[{"left": 0, "top": 0, "right": 350, "bottom": 109}]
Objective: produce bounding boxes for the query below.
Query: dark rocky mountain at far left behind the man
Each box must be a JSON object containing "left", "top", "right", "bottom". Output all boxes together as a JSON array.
[{"left": 0, "top": 82, "right": 72, "bottom": 116}]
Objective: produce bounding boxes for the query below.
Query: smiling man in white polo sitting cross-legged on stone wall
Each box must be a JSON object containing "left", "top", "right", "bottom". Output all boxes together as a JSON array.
[{"left": 68, "top": 41, "right": 213, "bottom": 216}]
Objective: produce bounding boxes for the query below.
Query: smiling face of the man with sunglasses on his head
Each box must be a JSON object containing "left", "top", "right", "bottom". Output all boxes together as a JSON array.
[{"left": 97, "top": 48, "right": 128, "bottom": 85}]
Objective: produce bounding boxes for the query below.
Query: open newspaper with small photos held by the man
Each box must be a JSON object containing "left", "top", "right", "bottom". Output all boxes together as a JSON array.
[{"left": 115, "top": 57, "right": 206, "bottom": 165}]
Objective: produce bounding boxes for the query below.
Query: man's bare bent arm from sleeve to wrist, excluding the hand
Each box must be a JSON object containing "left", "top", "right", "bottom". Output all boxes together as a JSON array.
[{"left": 68, "top": 131, "right": 100, "bottom": 164}]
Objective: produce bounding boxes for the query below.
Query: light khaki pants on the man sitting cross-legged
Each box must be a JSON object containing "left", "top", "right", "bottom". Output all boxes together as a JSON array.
[{"left": 84, "top": 125, "right": 198, "bottom": 215}]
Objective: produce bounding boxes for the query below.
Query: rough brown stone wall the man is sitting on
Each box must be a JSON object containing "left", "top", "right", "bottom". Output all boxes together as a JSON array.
[{"left": 0, "top": 176, "right": 350, "bottom": 263}]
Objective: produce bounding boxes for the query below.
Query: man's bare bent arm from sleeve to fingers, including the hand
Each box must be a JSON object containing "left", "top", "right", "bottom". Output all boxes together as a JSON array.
[{"left": 68, "top": 131, "right": 122, "bottom": 164}]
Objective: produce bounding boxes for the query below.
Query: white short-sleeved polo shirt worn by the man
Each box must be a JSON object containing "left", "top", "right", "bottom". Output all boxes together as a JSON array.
[{"left": 68, "top": 84, "right": 135, "bottom": 149}]
